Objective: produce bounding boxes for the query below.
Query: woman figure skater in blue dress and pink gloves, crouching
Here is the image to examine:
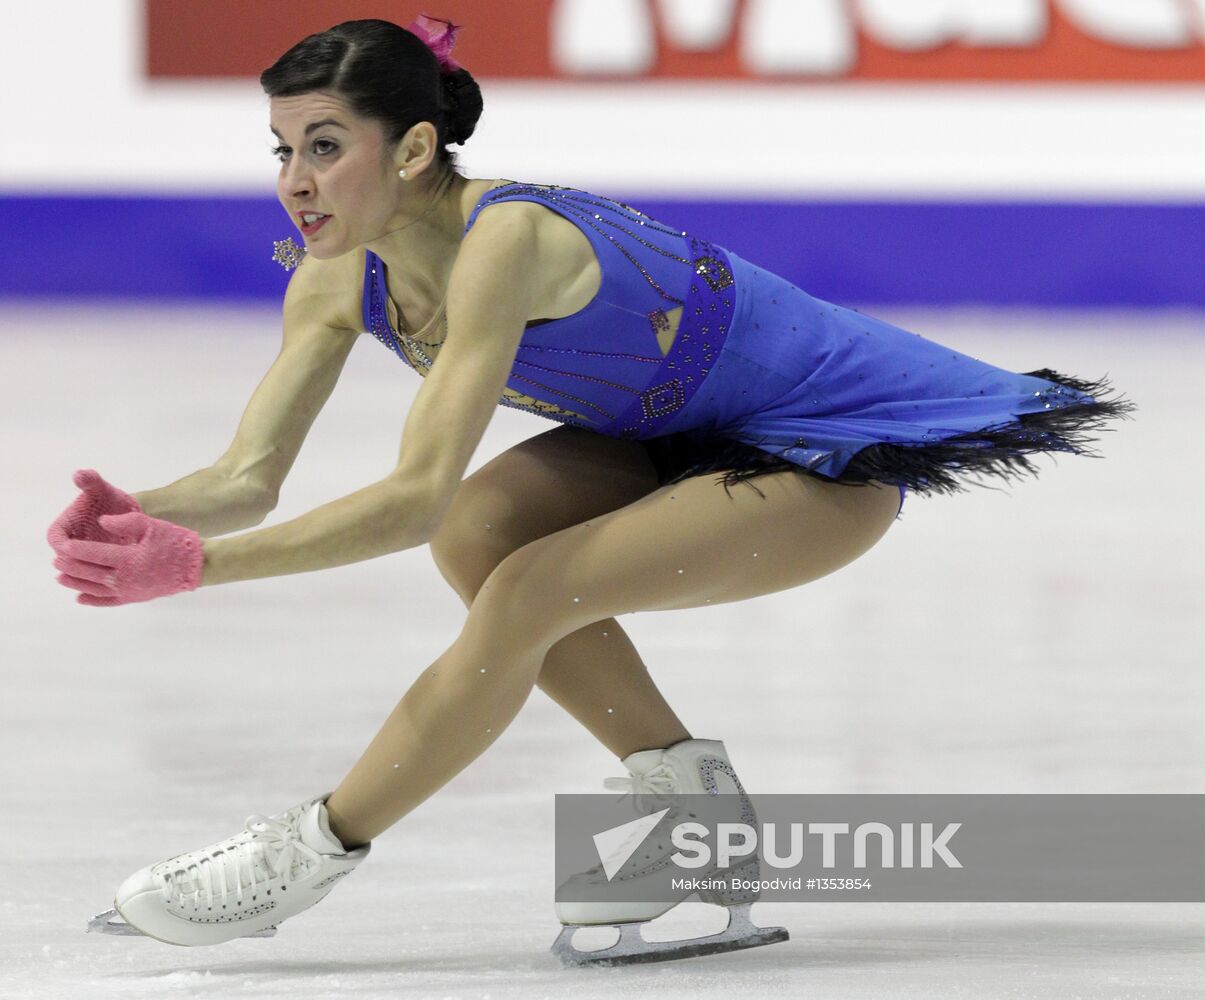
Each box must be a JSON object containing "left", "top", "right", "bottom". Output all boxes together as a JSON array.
[{"left": 49, "top": 18, "right": 1131, "bottom": 960}]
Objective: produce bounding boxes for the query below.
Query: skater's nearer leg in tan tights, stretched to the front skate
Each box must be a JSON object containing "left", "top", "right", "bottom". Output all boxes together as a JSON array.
[{"left": 327, "top": 472, "right": 899, "bottom": 846}]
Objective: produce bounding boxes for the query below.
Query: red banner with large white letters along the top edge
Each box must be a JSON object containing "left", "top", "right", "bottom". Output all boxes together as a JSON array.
[{"left": 146, "top": 0, "right": 1205, "bottom": 82}]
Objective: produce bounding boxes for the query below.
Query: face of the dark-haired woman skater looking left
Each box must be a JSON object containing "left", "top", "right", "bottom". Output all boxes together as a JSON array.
[{"left": 271, "top": 90, "right": 401, "bottom": 260}]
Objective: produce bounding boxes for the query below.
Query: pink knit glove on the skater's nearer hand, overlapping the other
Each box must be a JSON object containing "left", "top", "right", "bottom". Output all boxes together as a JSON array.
[{"left": 54, "top": 511, "right": 205, "bottom": 607}]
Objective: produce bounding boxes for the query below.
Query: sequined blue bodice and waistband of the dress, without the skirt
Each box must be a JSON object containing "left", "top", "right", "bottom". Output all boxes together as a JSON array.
[{"left": 364, "top": 183, "right": 735, "bottom": 439}]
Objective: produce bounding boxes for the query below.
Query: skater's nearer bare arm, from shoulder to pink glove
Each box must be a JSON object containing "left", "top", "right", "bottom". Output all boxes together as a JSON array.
[{"left": 201, "top": 213, "right": 539, "bottom": 586}]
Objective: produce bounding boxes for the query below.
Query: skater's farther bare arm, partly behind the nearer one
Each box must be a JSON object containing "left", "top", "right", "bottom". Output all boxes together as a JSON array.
[{"left": 134, "top": 254, "right": 357, "bottom": 539}]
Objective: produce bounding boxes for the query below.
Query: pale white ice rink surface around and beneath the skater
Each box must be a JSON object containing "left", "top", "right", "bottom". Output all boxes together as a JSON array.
[{"left": 0, "top": 304, "right": 1205, "bottom": 1000}]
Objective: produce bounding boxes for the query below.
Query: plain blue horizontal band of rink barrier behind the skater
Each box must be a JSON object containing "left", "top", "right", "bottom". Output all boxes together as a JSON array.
[{"left": 0, "top": 192, "right": 1205, "bottom": 307}]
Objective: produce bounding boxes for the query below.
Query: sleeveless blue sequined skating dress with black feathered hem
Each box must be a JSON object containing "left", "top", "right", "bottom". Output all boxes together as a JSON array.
[{"left": 364, "top": 182, "right": 1134, "bottom": 495}]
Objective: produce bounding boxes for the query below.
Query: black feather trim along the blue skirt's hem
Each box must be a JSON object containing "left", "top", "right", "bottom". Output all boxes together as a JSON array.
[{"left": 642, "top": 369, "right": 1136, "bottom": 496}]
